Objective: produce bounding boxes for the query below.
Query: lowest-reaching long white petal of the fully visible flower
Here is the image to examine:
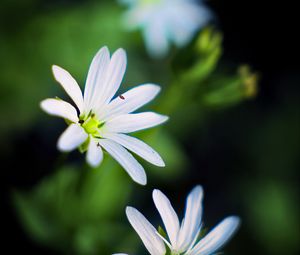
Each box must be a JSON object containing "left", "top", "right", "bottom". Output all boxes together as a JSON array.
[{"left": 98, "top": 139, "right": 147, "bottom": 185}]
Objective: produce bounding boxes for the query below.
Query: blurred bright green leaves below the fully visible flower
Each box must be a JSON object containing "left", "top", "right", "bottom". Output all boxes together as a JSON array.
[{"left": 14, "top": 157, "right": 137, "bottom": 254}]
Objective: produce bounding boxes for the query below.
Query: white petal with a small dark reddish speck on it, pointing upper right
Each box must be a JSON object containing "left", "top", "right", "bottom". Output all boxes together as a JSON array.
[{"left": 99, "top": 84, "right": 160, "bottom": 121}]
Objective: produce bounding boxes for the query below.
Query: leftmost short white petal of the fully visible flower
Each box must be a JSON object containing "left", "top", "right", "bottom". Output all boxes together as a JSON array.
[{"left": 40, "top": 98, "right": 78, "bottom": 122}]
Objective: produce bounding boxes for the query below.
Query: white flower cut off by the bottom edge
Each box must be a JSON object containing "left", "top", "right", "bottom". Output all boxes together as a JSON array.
[{"left": 119, "top": 186, "right": 240, "bottom": 255}]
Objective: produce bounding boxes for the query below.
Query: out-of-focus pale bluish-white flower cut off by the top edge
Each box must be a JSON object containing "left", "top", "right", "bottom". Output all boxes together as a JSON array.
[{"left": 119, "top": 0, "right": 212, "bottom": 57}]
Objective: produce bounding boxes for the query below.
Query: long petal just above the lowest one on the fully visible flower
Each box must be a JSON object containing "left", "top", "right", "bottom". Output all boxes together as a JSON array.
[{"left": 104, "top": 133, "right": 165, "bottom": 167}]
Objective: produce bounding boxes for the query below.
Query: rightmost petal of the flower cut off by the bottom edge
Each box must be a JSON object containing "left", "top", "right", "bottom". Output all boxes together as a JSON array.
[{"left": 188, "top": 216, "right": 240, "bottom": 255}]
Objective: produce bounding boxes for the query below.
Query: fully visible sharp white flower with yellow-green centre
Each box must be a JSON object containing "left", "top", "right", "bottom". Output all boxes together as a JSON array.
[{"left": 41, "top": 47, "right": 168, "bottom": 185}]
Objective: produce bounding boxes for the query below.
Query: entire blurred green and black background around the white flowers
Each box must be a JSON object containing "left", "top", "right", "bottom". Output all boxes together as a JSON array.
[{"left": 0, "top": 0, "right": 300, "bottom": 255}]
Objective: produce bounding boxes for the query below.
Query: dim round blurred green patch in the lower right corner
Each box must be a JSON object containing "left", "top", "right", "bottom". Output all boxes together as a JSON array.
[{"left": 247, "top": 181, "right": 300, "bottom": 255}]
